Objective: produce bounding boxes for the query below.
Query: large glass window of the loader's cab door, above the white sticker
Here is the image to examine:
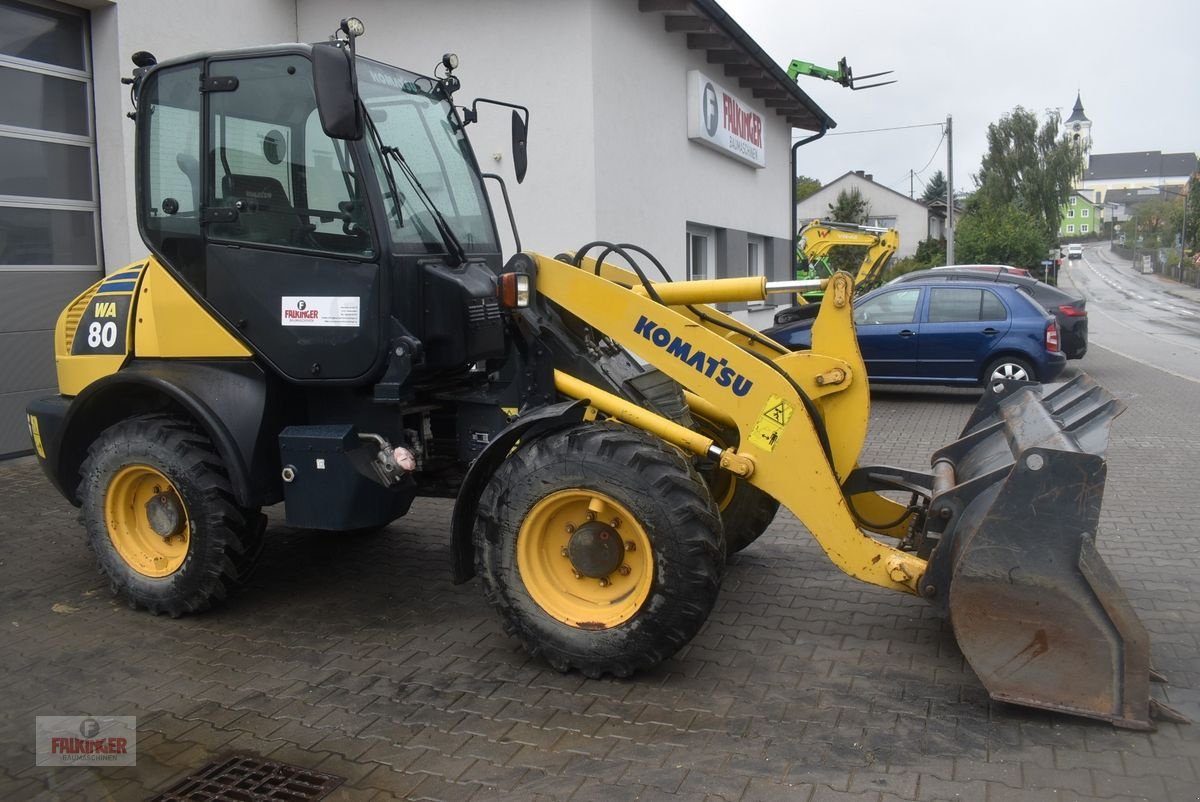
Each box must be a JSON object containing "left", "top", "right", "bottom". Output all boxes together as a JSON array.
[{"left": 208, "top": 55, "right": 372, "bottom": 256}]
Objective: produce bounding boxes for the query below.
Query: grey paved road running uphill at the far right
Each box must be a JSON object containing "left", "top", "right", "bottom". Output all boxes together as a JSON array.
[{"left": 1060, "top": 244, "right": 1200, "bottom": 382}]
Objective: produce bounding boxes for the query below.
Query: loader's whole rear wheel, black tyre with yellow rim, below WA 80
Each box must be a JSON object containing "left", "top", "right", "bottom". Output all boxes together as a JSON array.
[{"left": 78, "top": 414, "right": 266, "bottom": 617}]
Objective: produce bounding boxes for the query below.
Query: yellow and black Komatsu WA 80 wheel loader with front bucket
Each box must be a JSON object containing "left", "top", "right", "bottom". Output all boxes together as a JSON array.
[{"left": 28, "top": 19, "right": 1185, "bottom": 728}]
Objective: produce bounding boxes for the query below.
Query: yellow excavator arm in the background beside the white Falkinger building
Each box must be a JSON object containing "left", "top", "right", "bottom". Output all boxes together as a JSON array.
[{"left": 775, "top": 220, "right": 900, "bottom": 325}]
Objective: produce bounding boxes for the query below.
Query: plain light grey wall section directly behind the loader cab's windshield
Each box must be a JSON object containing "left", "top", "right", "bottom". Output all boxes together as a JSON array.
[{"left": 296, "top": 0, "right": 596, "bottom": 260}]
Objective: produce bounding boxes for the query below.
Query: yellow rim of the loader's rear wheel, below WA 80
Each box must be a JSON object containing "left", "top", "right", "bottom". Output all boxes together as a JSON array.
[{"left": 104, "top": 465, "right": 191, "bottom": 579}]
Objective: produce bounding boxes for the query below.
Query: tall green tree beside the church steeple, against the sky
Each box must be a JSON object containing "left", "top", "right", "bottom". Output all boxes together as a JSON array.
[{"left": 969, "top": 106, "right": 1082, "bottom": 249}]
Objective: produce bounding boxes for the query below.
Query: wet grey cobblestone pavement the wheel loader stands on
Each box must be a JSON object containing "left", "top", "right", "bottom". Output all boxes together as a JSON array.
[{"left": 0, "top": 349, "right": 1200, "bottom": 802}]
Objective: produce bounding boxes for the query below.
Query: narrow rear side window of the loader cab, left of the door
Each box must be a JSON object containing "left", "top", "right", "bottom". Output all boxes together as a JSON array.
[{"left": 139, "top": 62, "right": 203, "bottom": 279}]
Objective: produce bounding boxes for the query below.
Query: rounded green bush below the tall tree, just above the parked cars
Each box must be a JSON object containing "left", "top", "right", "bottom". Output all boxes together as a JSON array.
[{"left": 954, "top": 202, "right": 1046, "bottom": 268}]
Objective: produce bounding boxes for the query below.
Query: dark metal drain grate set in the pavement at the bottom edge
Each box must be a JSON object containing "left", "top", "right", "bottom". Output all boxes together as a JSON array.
[{"left": 150, "top": 755, "right": 344, "bottom": 802}]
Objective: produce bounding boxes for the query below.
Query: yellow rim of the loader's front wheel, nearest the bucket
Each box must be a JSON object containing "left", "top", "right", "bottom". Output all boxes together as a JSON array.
[{"left": 517, "top": 489, "right": 654, "bottom": 629}]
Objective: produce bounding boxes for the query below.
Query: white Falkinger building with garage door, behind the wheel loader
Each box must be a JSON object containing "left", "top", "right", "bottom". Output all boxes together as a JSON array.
[{"left": 0, "top": 0, "right": 833, "bottom": 455}]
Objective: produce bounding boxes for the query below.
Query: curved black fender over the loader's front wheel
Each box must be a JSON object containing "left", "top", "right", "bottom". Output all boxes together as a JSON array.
[{"left": 450, "top": 401, "right": 588, "bottom": 585}]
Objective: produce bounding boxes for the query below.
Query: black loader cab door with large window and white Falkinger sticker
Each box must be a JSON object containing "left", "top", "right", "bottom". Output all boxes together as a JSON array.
[{"left": 200, "top": 54, "right": 385, "bottom": 382}]
